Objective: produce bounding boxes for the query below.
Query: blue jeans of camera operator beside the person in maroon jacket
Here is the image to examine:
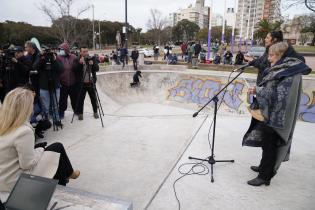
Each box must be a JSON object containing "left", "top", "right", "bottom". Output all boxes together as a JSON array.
[{"left": 39, "top": 88, "right": 60, "bottom": 122}]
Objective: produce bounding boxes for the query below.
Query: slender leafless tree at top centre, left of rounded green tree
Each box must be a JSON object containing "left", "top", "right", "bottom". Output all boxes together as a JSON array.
[{"left": 147, "top": 9, "right": 167, "bottom": 45}]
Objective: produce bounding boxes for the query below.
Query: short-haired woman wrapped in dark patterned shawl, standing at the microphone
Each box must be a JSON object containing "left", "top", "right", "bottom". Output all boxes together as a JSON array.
[{"left": 243, "top": 42, "right": 312, "bottom": 186}]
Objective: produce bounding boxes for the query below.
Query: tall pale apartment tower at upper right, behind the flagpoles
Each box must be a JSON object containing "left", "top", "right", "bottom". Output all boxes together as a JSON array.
[{"left": 236, "top": 0, "right": 281, "bottom": 40}]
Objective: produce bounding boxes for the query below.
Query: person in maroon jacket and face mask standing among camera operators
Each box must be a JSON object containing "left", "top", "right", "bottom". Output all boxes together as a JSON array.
[{"left": 57, "top": 42, "right": 79, "bottom": 119}]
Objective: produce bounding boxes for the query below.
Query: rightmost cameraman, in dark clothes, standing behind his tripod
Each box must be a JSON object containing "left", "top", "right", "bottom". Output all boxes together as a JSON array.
[{"left": 76, "top": 47, "right": 99, "bottom": 120}]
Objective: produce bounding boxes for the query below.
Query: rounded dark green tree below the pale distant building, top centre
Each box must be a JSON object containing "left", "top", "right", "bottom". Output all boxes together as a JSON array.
[{"left": 173, "top": 19, "right": 200, "bottom": 41}]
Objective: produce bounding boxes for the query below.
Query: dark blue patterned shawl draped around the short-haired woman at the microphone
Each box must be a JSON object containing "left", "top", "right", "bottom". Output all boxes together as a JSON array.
[{"left": 243, "top": 57, "right": 311, "bottom": 170}]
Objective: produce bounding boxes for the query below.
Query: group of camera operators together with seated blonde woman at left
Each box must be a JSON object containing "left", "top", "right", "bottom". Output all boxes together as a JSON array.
[{"left": 0, "top": 41, "right": 105, "bottom": 195}]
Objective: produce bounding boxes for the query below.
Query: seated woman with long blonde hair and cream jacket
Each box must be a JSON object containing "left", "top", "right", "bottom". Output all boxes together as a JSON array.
[{"left": 0, "top": 88, "right": 80, "bottom": 192}]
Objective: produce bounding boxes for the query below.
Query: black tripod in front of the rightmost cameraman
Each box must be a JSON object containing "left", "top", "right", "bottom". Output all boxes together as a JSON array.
[{"left": 71, "top": 62, "right": 104, "bottom": 128}]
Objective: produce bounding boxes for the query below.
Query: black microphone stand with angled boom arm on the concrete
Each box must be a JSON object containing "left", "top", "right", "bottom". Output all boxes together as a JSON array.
[{"left": 188, "top": 65, "right": 249, "bottom": 182}]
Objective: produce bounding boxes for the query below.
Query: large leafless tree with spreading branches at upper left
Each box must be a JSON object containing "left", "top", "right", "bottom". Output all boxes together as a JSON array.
[{"left": 39, "top": 0, "right": 90, "bottom": 45}]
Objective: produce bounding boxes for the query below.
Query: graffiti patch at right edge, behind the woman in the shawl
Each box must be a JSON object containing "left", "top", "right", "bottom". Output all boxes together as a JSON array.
[{"left": 299, "top": 91, "right": 315, "bottom": 123}]
